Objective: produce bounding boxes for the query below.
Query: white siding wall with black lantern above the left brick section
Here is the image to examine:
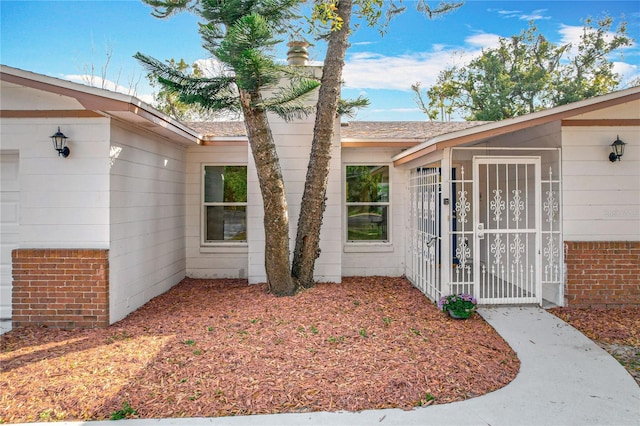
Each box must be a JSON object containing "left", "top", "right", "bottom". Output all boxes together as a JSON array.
[{"left": 0, "top": 117, "right": 109, "bottom": 248}]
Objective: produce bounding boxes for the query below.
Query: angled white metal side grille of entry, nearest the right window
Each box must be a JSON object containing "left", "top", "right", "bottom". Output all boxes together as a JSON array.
[{"left": 406, "top": 167, "right": 441, "bottom": 300}]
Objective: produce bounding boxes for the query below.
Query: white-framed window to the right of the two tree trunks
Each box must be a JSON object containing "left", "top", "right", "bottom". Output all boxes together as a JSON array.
[{"left": 345, "top": 165, "right": 390, "bottom": 242}]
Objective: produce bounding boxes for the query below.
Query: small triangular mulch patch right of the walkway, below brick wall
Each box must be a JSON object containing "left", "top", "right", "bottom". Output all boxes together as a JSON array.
[{"left": 549, "top": 306, "right": 640, "bottom": 385}]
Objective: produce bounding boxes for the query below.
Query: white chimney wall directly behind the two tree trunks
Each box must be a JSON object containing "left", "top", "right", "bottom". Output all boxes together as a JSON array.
[{"left": 247, "top": 116, "right": 342, "bottom": 283}]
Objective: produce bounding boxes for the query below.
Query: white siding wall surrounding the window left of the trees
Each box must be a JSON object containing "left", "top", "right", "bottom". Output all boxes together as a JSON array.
[{"left": 185, "top": 145, "right": 250, "bottom": 278}]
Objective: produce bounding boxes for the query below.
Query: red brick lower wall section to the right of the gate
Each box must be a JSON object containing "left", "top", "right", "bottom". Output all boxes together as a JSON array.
[{"left": 565, "top": 241, "right": 640, "bottom": 308}]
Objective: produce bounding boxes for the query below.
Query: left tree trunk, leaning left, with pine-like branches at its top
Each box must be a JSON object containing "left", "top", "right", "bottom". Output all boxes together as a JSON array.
[{"left": 239, "top": 89, "right": 297, "bottom": 296}]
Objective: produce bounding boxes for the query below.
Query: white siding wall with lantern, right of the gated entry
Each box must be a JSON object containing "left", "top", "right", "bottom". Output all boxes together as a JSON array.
[{"left": 562, "top": 125, "right": 640, "bottom": 241}]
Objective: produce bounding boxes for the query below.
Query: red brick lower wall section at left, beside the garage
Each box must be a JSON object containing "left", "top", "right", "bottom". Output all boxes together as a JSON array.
[{"left": 12, "top": 249, "right": 109, "bottom": 328}]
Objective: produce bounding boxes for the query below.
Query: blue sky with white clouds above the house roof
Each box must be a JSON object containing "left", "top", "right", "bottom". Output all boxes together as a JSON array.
[{"left": 0, "top": 0, "right": 640, "bottom": 121}]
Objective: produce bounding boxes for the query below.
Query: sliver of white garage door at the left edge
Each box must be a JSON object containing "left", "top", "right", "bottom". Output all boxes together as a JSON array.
[{"left": 0, "top": 153, "right": 19, "bottom": 333}]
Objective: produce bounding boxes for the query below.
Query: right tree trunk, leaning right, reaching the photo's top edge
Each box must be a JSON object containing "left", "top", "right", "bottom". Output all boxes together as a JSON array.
[{"left": 291, "top": 0, "right": 352, "bottom": 288}]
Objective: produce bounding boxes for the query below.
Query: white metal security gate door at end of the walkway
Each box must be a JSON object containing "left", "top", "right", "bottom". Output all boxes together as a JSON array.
[{"left": 473, "top": 157, "right": 542, "bottom": 304}]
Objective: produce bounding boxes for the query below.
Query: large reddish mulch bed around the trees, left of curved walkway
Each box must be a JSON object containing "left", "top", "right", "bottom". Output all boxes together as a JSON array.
[{"left": 0, "top": 277, "right": 520, "bottom": 423}]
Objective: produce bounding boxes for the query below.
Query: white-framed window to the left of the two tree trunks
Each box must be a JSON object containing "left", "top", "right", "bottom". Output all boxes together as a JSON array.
[{"left": 202, "top": 165, "right": 247, "bottom": 244}]
